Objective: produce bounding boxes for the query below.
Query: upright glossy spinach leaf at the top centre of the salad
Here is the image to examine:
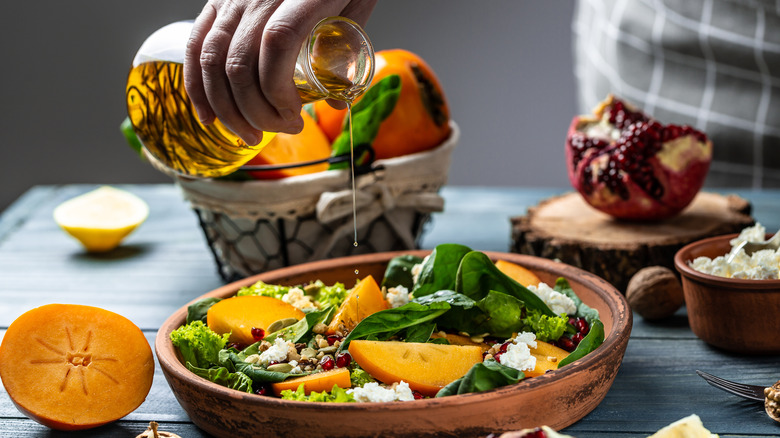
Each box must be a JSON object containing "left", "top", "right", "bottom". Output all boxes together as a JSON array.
[{"left": 412, "top": 243, "right": 471, "bottom": 297}]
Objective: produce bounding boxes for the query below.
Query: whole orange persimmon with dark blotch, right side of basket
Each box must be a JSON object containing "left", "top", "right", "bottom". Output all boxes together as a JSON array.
[{"left": 314, "top": 49, "right": 451, "bottom": 159}]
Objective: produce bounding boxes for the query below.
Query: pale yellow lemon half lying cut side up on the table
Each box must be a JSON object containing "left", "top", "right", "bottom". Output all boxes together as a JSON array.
[{"left": 54, "top": 186, "right": 149, "bottom": 252}]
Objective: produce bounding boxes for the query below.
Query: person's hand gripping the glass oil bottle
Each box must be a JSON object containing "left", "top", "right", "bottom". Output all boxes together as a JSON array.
[{"left": 184, "top": 0, "right": 377, "bottom": 145}]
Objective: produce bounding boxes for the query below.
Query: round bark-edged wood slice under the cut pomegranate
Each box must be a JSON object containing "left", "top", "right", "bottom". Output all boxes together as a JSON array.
[{"left": 511, "top": 192, "right": 755, "bottom": 293}]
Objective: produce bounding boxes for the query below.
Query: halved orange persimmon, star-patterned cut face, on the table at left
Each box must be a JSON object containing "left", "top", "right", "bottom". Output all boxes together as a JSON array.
[{"left": 0, "top": 304, "right": 154, "bottom": 430}]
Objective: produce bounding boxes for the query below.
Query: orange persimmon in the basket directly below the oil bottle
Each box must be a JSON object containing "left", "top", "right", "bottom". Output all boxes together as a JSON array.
[{"left": 246, "top": 110, "right": 330, "bottom": 179}]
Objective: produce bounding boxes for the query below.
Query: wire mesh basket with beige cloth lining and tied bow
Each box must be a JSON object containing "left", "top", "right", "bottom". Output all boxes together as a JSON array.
[{"left": 176, "top": 122, "right": 460, "bottom": 281}]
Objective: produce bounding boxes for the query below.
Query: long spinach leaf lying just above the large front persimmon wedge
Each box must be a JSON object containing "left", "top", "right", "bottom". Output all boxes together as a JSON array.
[{"left": 339, "top": 302, "right": 450, "bottom": 351}]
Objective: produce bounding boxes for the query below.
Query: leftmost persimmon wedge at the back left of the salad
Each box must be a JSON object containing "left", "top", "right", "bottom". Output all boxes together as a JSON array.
[{"left": 206, "top": 295, "right": 306, "bottom": 345}]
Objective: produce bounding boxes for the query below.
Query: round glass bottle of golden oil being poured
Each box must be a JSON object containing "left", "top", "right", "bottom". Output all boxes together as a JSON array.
[{"left": 126, "top": 17, "right": 374, "bottom": 177}]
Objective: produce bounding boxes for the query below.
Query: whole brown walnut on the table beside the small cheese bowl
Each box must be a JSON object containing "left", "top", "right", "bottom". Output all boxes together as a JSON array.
[{"left": 626, "top": 266, "right": 685, "bottom": 320}]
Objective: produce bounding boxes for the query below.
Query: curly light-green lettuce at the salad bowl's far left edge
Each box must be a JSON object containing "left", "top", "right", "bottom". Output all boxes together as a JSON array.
[{"left": 170, "top": 320, "right": 230, "bottom": 368}]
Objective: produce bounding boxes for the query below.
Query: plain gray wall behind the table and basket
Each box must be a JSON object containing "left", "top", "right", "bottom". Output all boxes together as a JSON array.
[{"left": 0, "top": 0, "right": 576, "bottom": 210}]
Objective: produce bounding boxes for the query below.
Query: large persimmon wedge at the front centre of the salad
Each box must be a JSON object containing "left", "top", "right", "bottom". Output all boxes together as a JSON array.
[{"left": 348, "top": 340, "right": 483, "bottom": 396}]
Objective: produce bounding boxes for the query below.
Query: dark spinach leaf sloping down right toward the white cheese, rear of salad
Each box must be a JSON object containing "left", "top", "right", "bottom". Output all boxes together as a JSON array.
[{"left": 455, "top": 251, "right": 556, "bottom": 316}]
